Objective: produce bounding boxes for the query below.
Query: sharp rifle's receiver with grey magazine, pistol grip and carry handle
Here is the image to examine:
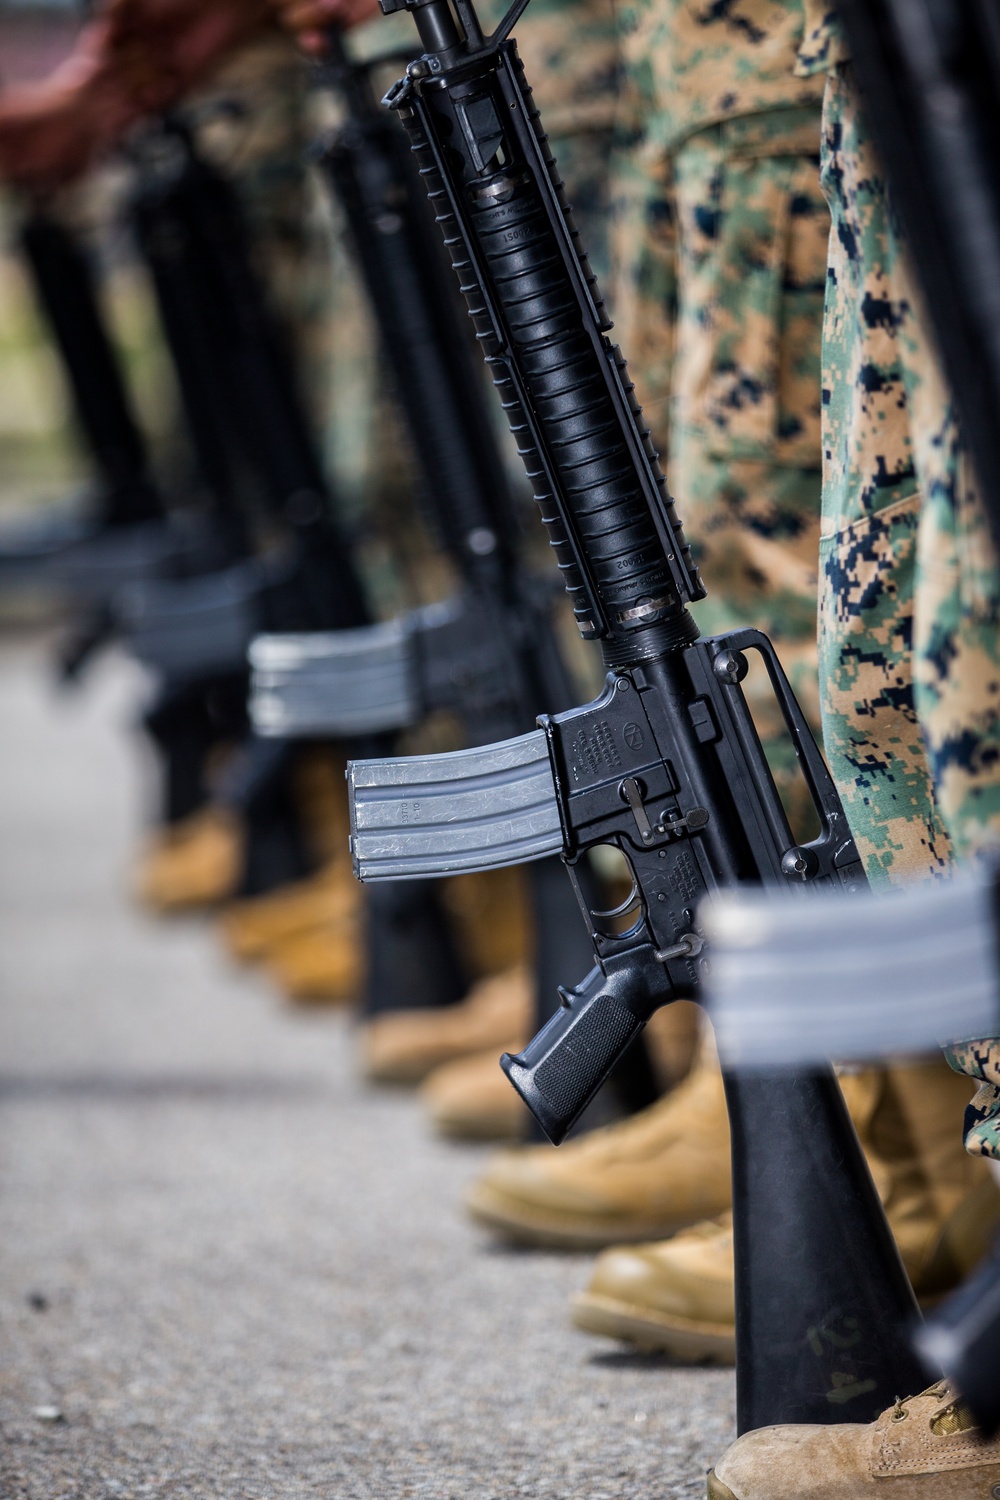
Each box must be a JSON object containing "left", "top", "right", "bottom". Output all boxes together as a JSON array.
[{"left": 348, "top": 630, "right": 864, "bottom": 1142}]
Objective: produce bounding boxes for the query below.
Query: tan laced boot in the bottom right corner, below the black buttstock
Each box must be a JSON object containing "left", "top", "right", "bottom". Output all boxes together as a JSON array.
[{"left": 708, "top": 1382, "right": 1000, "bottom": 1500}]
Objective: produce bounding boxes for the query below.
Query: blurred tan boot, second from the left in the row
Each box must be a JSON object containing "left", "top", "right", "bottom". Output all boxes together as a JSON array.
[{"left": 219, "top": 860, "right": 363, "bottom": 963}]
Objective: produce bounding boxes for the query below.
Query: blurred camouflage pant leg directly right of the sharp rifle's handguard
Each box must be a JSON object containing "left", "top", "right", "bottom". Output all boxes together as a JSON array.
[{"left": 618, "top": 110, "right": 829, "bottom": 815}]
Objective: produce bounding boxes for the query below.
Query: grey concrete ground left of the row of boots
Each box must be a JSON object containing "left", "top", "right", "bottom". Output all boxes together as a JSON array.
[{"left": 0, "top": 642, "right": 733, "bottom": 1500}]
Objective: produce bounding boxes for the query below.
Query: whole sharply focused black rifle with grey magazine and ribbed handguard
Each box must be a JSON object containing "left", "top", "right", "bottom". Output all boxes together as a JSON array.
[{"left": 349, "top": 0, "right": 919, "bottom": 1430}]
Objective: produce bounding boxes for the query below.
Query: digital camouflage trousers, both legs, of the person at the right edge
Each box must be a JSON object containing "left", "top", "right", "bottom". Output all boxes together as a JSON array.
[{"left": 820, "top": 66, "right": 1000, "bottom": 1157}]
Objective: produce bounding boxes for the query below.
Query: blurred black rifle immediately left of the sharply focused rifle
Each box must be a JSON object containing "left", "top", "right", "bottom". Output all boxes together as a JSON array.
[{"left": 254, "top": 30, "right": 657, "bottom": 1109}]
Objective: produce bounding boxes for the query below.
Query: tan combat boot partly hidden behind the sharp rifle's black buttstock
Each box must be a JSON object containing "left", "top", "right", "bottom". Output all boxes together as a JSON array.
[{"left": 573, "top": 1058, "right": 1000, "bottom": 1364}]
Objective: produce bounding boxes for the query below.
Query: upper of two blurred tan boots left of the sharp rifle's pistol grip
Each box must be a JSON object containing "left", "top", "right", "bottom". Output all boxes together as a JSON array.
[{"left": 361, "top": 965, "right": 534, "bottom": 1092}]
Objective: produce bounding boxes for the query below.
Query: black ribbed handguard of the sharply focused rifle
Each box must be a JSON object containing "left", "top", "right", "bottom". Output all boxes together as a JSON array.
[{"left": 389, "top": 42, "right": 703, "bottom": 654}]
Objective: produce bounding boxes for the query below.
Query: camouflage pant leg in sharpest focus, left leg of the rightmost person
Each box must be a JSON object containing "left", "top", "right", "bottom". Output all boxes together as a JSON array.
[{"left": 819, "top": 69, "right": 951, "bottom": 885}]
